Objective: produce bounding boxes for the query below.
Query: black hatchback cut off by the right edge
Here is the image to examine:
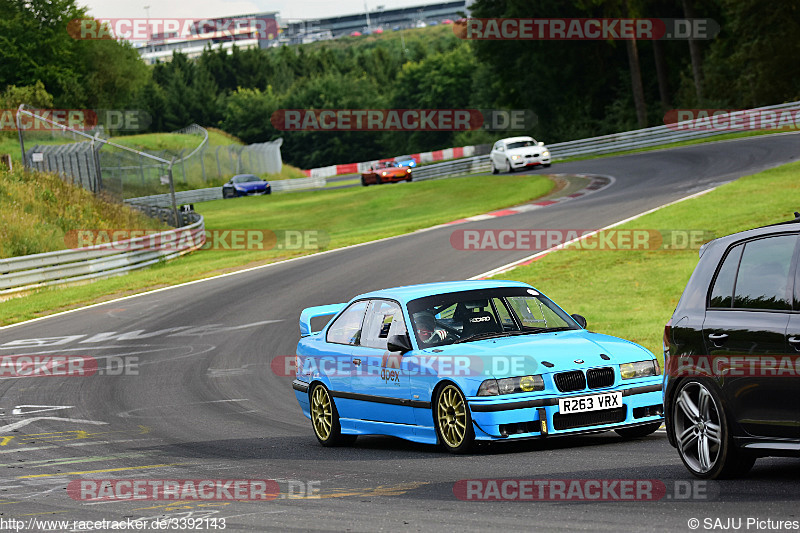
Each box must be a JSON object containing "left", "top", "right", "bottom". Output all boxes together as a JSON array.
[{"left": 664, "top": 213, "right": 800, "bottom": 479}]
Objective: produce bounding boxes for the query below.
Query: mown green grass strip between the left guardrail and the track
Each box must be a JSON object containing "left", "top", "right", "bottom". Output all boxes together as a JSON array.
[{"left": 0, "top": 175, "right": 553, "bottom": 324}]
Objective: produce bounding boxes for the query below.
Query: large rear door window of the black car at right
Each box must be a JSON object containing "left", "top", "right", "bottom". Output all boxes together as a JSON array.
[{"left": 733, "top": 235, "right": 797, "bottom": 310}]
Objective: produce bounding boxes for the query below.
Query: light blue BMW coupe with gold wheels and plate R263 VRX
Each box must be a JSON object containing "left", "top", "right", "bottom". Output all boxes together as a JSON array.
[{"left": 292, "top": 281, "right": 663, "bottom": 453}]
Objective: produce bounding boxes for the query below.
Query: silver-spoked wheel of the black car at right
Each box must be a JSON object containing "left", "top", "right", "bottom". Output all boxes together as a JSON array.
[{"left": 670, "top": 379, "right": 755, "bottom": 479}]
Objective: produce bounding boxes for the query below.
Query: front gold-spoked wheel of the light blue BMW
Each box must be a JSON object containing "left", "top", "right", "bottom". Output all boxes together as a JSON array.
[{"left": 433, "top": 383, "right": 475, "bottom": 454}]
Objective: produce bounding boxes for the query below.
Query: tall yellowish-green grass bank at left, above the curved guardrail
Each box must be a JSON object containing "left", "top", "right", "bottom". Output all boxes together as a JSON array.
[{"left": 0, "top": 168, "right": 167, "bottom": 257}]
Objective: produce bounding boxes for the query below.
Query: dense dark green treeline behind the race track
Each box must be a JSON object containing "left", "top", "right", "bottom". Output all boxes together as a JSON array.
[{"left": 0, "top": 0, "right": 800, "bottom": 168}]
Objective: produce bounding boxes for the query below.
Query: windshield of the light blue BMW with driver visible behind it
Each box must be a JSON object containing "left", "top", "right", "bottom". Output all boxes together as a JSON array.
[{"left": 408, "top": 287, "right": 580, "bottom": 348}]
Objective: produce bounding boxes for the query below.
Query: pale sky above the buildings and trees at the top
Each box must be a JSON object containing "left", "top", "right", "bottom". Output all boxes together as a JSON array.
[{"left": 76, "top": 0, "right": 446, "bottom": 20}]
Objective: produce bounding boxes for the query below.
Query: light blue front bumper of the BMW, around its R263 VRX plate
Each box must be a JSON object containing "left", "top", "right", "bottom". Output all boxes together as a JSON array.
[{"left": 468, "top": 382, "right": 664, "bottom": 440}]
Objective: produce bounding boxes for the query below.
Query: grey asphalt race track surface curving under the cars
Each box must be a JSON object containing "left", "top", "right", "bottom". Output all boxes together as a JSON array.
[{"left": 0, "top": 135, "right": 800, "bottom": 531}]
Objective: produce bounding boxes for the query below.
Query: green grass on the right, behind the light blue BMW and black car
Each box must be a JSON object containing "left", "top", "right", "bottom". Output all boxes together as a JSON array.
[{"left": 496, "top": 159, "right": 800, "bottom": 358}]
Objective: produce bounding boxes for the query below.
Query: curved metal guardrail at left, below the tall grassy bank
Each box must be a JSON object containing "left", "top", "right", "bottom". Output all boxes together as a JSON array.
[{"left": 0, "top": 213, "right": 206, "bottom": 294}]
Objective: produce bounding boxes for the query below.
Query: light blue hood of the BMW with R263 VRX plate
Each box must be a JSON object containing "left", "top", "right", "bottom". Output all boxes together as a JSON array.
[{"left": 414, "top": 330, "right": 654, "bottom": 379}]
